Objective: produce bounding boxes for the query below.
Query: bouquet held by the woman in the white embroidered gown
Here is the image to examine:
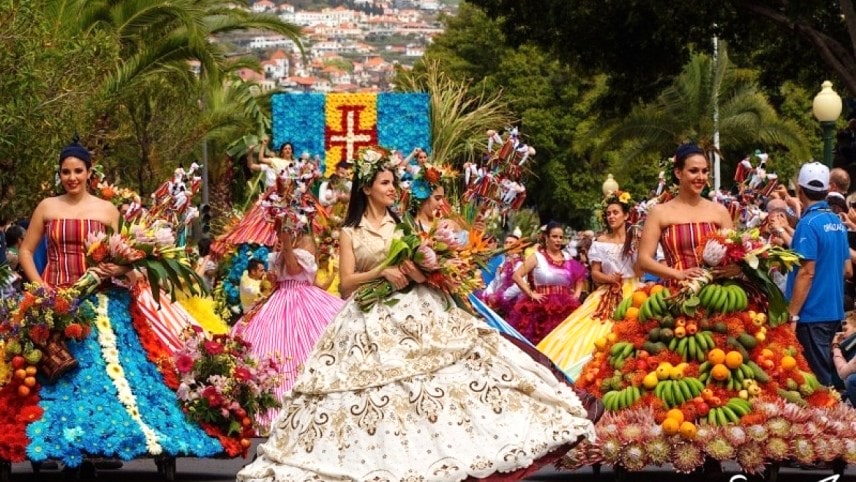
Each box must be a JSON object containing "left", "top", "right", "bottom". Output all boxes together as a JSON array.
[{"left": 356, "top": 218, "right": 504, "bottom": 311}]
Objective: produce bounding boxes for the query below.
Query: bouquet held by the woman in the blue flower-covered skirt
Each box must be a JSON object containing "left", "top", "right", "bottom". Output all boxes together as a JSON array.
[{"left": 83, "top": 218, "right": 204, "bottom": 302}]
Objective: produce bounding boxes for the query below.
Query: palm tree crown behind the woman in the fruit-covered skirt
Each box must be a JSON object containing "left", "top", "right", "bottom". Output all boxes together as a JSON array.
[{"left": 598, "top": 46, "right": 810, "bottom": 177}]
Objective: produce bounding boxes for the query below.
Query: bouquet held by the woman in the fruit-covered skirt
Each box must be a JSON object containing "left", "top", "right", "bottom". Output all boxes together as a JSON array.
[{"left": 677, "top": 228, "right": 800, "bottom": 326}]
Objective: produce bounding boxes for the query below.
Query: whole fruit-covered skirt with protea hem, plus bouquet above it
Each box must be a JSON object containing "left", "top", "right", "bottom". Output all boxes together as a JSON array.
[{"left": 564, "top": 230, "right": 856, "bottom": 474}]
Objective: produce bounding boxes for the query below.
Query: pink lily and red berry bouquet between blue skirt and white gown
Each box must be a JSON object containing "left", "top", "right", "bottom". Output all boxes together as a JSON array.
[{"left": 173, "top": 332, "right": 280, "bottom": 456}]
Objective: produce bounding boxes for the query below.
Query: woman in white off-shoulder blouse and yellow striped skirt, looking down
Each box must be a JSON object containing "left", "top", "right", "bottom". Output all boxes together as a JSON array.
[{"left": 538, "top": 191, "right": 639, "bottom": 379}]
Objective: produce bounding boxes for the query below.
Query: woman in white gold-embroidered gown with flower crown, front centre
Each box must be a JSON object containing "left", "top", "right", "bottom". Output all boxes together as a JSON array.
[{"left": 238, "top": 151, "right": 594, "bottom": 482}]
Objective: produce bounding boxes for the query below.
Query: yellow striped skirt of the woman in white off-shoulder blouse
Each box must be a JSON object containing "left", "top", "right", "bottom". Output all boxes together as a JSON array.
[{"left": 537, "top": 278, "right": 639, "bottom": 380}]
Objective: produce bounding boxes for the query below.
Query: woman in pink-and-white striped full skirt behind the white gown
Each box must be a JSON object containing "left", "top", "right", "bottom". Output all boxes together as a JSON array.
[{"left": 232, "top": 227, "right": 345, "bottom": 433}]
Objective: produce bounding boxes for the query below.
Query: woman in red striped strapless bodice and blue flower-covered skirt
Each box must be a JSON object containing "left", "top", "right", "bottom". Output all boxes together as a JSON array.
[{"left": 0, "top": 141, "right": 222, "bottom": 467}]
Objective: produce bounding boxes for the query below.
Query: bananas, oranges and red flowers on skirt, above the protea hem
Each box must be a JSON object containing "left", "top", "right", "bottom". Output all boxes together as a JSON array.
[{"left": 577, "top": 281, "right": 838, "bottom": 436}]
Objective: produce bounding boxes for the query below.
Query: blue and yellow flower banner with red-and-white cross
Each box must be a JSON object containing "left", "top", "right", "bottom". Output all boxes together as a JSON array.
[{"left": 272, "top": 93, "right": 431, "bottom": 169}]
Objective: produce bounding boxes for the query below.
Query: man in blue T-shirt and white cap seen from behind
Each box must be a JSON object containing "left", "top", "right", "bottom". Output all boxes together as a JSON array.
[{"left": 786, "top": 162, "right": 853, "bottom": 386}]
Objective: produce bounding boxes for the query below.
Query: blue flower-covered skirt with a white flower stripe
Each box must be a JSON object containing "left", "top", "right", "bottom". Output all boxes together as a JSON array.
[{"left": 26, "top": 289, "right": 223, "bottom": 467}]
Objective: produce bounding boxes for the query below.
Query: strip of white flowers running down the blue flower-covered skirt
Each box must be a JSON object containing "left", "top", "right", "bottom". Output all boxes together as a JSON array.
[{"left": 95, "top": 295, "right": 163, "bottom": 455}]
